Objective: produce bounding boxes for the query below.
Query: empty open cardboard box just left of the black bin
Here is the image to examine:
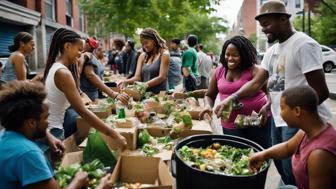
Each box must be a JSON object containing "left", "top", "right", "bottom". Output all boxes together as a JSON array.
[{"left": 111, "top": 155, "right": 173, "bottom": 189}]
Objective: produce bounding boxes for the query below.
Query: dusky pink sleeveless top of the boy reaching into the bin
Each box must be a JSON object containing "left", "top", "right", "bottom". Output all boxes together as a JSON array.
[{"left": 292, "top": 125, "right": 336, "bottom": 189}]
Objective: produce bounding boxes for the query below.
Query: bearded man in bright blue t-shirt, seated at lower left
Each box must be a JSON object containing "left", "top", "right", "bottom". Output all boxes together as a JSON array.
[{"left": 0, "top": 81, "right": 112, "bottom": 189}]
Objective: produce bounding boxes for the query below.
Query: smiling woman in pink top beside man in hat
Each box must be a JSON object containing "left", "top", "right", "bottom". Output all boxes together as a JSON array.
[{"left": 201, "top": 36, "right": 273, "bottom": 148}]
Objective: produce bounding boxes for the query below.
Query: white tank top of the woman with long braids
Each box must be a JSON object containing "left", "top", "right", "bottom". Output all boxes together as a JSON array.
[{"left": 45, "top": 62, "right": 70, "bottom": 130}]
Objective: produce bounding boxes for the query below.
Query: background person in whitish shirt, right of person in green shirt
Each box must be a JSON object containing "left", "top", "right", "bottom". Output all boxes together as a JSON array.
[{"left": 196, "top": 44, "right": 212, "bottom": 89}]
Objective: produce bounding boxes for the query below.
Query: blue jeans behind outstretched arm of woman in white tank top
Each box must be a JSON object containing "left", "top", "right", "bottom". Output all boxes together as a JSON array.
[{"left": 63, "top": 106, "right": 79, "bottom": 138}]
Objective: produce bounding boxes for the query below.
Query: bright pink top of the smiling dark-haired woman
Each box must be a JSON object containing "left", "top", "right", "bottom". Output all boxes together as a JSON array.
[{"left": 215, "top": 66, "right": 267, "bottom": 129}]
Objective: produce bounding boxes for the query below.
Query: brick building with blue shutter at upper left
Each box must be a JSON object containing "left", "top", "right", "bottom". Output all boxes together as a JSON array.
[{"left": 0, "top": 0, "right": 87, "bottom": 70}]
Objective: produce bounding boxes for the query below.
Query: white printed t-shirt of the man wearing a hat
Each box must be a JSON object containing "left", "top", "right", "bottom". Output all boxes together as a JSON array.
[{"left": 261, "top": 32, "right": 332, "bottom": 127}]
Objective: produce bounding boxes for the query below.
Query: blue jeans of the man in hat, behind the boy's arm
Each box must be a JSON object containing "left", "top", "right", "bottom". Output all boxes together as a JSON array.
[{"left": 272, "top": 122, "right": 299, "bottom": 186}]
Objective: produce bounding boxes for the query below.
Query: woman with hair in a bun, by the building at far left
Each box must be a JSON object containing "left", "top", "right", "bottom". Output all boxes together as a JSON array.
[{"left": 1, "top": 32, "right": 35, "bottom": 82}]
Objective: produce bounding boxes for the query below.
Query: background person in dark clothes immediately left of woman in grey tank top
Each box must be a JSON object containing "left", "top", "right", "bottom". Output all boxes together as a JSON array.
[{"left": 125, "top": 40, "right": 138, "bottom": 79}]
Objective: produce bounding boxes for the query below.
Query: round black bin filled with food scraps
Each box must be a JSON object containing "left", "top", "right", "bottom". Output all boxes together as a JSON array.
[{"left": 171, "top": 135, "right": 270, "bottom": 189}]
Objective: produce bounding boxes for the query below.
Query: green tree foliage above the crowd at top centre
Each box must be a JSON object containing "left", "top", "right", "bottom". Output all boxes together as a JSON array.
[{"left": 80, "top": 0, "right": 227, "bottom": 50}]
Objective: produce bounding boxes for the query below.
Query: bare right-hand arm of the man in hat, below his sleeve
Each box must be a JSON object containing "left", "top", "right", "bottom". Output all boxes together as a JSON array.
[{"left": 305, "top": 69, "right": 329, "bottom": 104}]
